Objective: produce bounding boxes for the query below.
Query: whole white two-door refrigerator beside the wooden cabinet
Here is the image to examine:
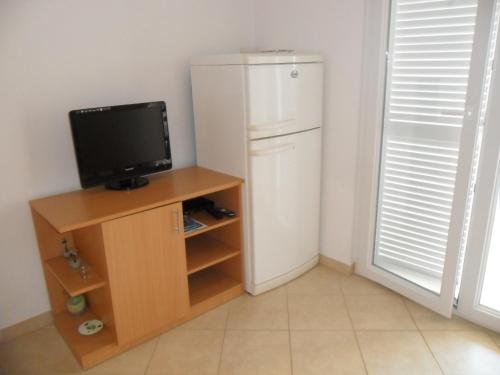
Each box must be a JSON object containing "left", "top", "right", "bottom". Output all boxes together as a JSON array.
[{"left": 191, "top": 53, "right": 323, "bottom": 294}]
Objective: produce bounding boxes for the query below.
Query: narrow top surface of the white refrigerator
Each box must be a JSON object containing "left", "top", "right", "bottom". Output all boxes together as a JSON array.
[{"left": 191, "top": 51, "right": 323, "bottom": 66}]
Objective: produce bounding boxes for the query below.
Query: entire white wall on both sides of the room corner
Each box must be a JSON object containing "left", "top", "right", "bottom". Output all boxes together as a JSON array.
[{"left": 0, "top": 0, "right": 363, "bottom": 329}]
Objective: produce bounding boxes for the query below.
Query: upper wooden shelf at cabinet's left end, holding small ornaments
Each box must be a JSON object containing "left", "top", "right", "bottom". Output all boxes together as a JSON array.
[{"left": 45, "top": 256, "right": 106, "bottom": 297}]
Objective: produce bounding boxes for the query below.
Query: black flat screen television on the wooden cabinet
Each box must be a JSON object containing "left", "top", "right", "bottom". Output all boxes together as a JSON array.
[{"left": 69, "top": 101, "right": 172, "bottom": 190}]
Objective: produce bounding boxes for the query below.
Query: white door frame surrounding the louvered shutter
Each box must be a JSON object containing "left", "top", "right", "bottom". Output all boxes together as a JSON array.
[{"left": 352, "top": 0, "right": 494, "bottom": 317}]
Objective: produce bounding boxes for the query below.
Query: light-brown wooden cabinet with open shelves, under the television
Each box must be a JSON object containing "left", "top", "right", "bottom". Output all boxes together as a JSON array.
[{"left": 30, "top": 167, "right": 243, "bottom": 369}]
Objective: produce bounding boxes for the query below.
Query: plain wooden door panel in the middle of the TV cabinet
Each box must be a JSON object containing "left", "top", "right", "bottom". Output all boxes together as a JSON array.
[{"left": 103, "top": 203, "right": 189, "bottom": 344}]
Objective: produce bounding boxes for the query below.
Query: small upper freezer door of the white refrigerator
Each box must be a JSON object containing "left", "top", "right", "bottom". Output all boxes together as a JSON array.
[{"left": 246, "top": 63, "right": 323, "bottom": 139}]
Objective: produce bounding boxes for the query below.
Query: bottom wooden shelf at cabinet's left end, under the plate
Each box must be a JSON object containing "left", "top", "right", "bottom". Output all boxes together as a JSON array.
[{"left": 54, "top": 311, "right": 117, "bottom": 357}]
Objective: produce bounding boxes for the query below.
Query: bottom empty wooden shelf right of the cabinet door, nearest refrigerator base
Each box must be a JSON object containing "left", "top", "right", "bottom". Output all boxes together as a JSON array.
[{"left": 189, "top": 268, "right": 242, "bottom": 306}]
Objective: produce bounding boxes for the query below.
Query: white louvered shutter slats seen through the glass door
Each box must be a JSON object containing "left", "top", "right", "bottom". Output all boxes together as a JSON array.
[{"left": 374, "top": 0, "right": 477, "bottom": 278}]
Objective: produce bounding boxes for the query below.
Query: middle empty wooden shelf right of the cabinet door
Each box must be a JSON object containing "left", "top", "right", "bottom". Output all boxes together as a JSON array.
[{"left": 186, "top": 235, "right": 240, "bottom": 275}]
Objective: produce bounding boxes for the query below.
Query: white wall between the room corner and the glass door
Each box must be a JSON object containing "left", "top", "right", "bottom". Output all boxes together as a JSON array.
[{"left": 255, "top": 0, "right": 364, "bottom": 264}]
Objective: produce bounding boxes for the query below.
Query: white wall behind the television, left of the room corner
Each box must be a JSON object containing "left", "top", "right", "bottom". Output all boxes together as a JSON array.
[{"left": 0, "top": 0, "right": 254, "bottom": 329}]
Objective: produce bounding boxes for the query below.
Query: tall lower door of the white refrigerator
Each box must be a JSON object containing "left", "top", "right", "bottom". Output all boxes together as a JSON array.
[{"left": 248, "top": 128, "right": 321, "bottom": 294}]
